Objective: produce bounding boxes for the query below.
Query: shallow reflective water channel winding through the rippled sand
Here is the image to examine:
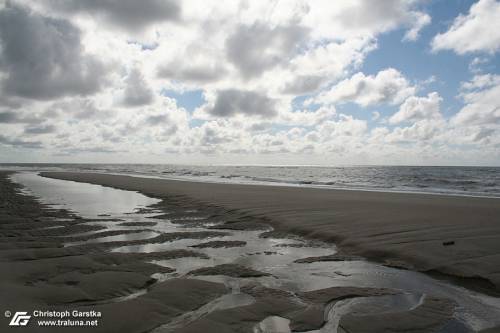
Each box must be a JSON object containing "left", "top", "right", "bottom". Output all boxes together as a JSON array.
[{"left": 12, "top": 172, "right": 500, "bottom": 333}]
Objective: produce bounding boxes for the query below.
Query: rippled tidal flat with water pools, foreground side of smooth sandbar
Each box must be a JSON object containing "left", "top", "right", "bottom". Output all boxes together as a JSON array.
[{"left": 0, "top": 173, "right": 500, "bottom": 332}]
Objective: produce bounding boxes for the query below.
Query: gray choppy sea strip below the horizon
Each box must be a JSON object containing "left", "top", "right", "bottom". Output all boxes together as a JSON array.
[{"left": 0, "top": 163, "right": 500, "bottom": 197}]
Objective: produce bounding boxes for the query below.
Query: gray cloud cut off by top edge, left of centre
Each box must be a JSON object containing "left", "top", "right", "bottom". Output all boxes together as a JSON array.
[{"left": 44, "top": 0, "right": 181, "bottom": 31}]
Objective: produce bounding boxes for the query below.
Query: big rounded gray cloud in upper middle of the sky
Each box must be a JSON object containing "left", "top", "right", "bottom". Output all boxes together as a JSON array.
[{"left": 226, "top": 24, "right": 308, "bottom": 78}]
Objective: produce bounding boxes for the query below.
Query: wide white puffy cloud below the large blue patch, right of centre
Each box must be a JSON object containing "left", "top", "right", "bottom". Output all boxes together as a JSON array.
[{"left": 315, "top": 68, "right": 415, "bottom": 107}]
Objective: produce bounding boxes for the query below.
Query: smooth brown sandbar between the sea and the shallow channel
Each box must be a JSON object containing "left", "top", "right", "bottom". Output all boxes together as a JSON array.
[{"left": 43, "top": 172, "right": 500, "bottom": 294}]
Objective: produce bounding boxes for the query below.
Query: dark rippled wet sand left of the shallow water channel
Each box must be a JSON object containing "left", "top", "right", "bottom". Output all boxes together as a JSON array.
[{"left": 0, "top": 172, "right": 227, "bottom": 332}]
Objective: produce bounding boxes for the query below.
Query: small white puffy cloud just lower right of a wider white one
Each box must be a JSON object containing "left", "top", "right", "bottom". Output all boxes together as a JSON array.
[{"left": 389, "top": 92, "right": 443, "bottom": 124}]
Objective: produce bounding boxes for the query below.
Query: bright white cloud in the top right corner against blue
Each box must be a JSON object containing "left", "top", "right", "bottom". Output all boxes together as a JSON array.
[{"left": 432, "top": 0, "right": 500, "bottom": 54}]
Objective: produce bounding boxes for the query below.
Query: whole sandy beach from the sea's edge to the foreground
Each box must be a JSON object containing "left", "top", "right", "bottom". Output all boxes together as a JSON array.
[{"left": 0, "top": 172, "right": 500, "bottom": 333}]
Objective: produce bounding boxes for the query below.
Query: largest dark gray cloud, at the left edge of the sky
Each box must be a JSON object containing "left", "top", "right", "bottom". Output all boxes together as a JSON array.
[{"left": 0, "top": 5, "right": 104, "bottom": 100}]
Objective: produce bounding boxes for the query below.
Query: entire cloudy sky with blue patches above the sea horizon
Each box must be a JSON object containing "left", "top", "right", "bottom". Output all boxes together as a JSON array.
[{"left": 0, "top": 0, "right": 500, "bottom": 166}]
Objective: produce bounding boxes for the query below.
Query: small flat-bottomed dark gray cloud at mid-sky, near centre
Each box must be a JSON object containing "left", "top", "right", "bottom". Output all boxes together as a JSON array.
[{"left": 208, "top": 89, "right": 276, "bottom": 117}]
